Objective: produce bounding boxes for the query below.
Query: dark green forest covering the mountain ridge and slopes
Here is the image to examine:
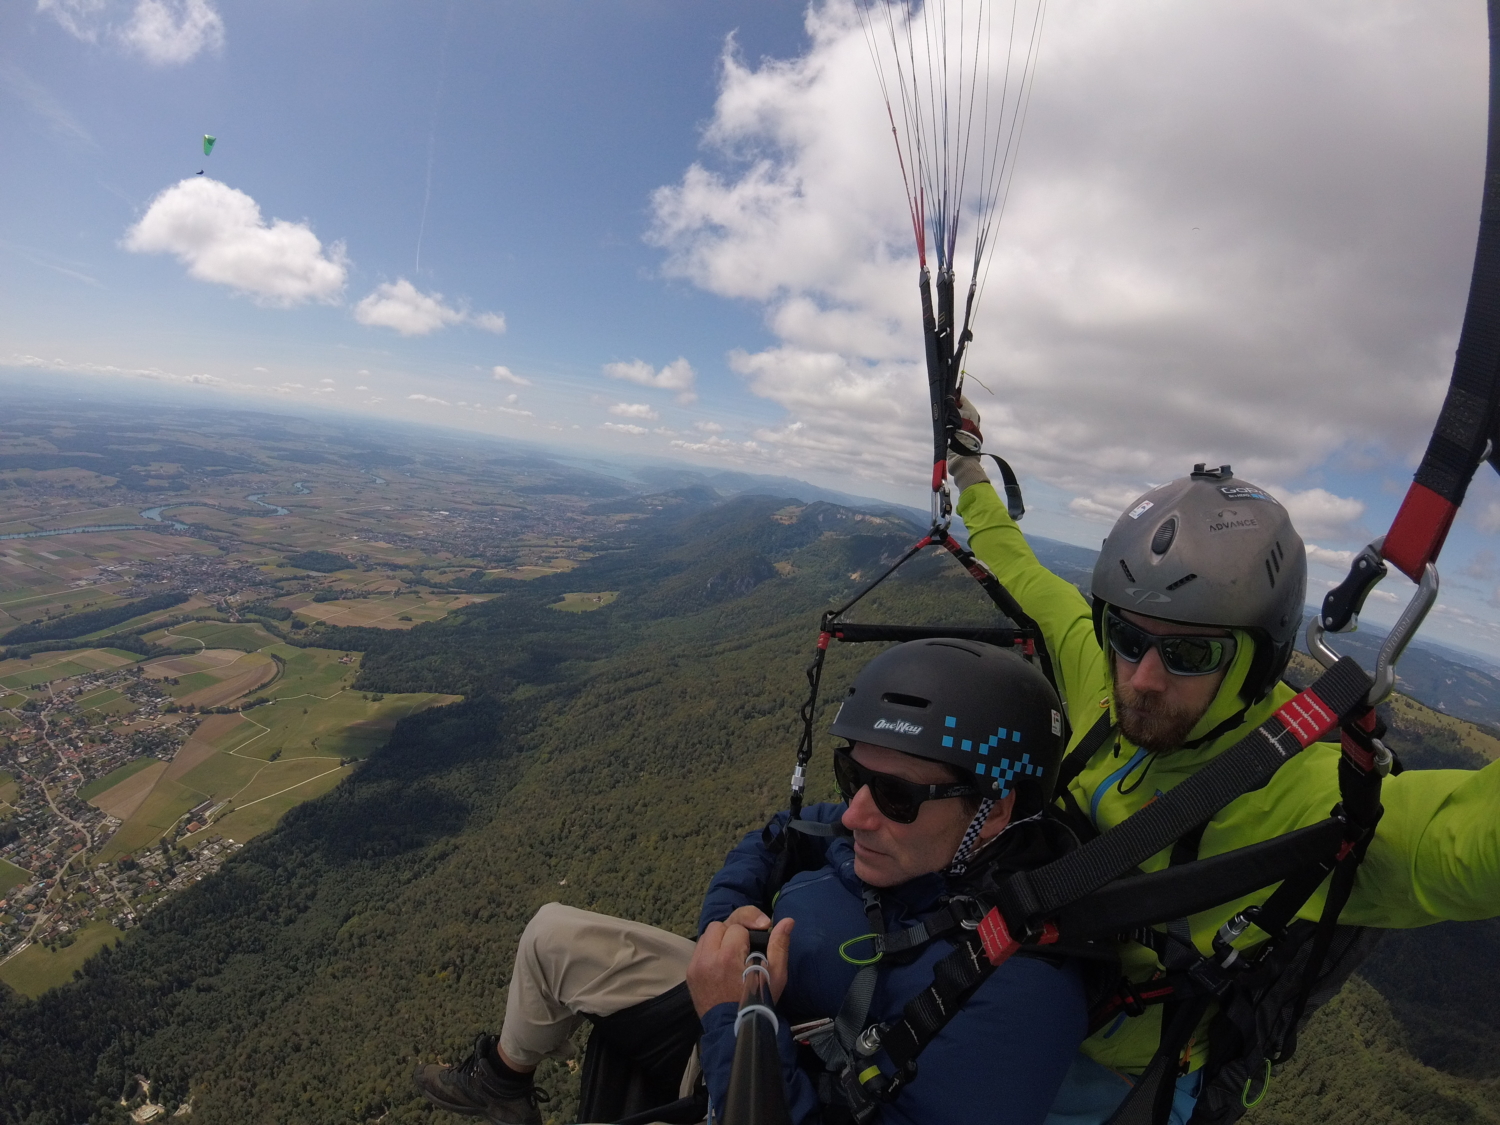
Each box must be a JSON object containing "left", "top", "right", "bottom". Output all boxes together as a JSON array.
[{"left": 0, "top": 501, "right": 1500, "bottom": 1125}]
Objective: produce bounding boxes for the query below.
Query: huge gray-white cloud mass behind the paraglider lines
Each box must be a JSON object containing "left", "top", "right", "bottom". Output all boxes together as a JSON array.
[{"left": 648, "top": 0, "right": 1485, "bottom": 510}]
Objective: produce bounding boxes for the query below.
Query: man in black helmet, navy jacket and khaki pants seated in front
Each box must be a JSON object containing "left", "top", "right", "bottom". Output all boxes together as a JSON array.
[{"left": 416, "top": 639, "right": 1088, "bottom": 1125}]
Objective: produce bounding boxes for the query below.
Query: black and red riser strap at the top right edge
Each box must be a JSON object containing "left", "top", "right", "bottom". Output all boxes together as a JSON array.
[{"left": 1382, "top": 0, "right": 1500, "bottom": 582}]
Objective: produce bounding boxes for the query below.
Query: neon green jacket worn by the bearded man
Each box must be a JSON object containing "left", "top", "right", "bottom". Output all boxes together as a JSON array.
[{"left": 959, "top": 485, "right": 1500, "bottom": 1073}]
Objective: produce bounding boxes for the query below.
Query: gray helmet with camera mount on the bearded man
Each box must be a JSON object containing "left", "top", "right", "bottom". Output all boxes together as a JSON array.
[{"left": 1092, "top": 465, "right": 1308, "bottom": 704}]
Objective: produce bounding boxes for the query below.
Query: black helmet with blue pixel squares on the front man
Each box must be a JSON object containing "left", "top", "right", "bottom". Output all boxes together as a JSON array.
[{"left": 833, "top": 638, "right": 1062, "bottom": 819}]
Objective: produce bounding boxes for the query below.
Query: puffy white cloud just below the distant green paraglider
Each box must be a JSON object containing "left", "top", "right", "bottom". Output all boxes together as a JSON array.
[{"left": 123, "top": 176, "right": 348, "bottom": 306}]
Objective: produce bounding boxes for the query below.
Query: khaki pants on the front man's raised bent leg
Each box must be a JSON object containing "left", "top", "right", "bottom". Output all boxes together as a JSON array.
[{"left": 500, "top": 903, "right": 698, "bottom": 1086}]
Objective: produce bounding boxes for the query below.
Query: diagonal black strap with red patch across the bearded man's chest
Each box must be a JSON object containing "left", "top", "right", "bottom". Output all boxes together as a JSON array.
[{"left": 996, "top": 657, "right": 1371, "bottom": 932}]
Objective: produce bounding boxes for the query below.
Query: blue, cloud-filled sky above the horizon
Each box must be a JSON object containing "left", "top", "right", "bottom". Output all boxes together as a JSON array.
[{"left": 0, "top": 0, "right": 1500, "bottom": 656}]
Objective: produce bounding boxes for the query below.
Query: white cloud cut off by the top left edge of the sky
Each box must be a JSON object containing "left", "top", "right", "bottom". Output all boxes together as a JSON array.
[{"left": 36, "top": 0, "right": 224, "bottom": 66}]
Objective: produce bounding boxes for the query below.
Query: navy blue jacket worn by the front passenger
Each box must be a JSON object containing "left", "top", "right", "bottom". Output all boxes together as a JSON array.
[{"left": 701, "top": 806, "right": 1088, "bottom": 1125}]
